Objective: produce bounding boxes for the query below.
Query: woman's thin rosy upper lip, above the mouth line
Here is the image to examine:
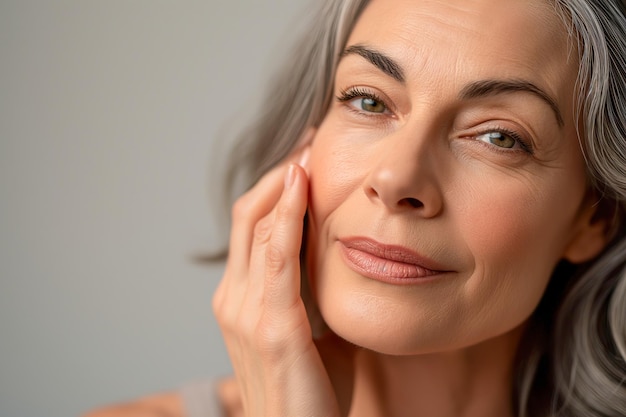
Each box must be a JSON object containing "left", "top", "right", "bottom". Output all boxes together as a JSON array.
[{"left": 339, "top": 237, "right": 448, "bottom": 272}]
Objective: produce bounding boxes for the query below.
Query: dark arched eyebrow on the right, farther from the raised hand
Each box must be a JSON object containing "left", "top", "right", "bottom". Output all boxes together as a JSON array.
[{"left": 459, "top": 80, "right": 564, "bottom": 127}]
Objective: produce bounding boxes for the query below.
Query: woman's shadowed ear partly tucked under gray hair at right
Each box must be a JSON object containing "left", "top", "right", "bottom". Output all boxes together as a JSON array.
[{"left": 563, "top": 194, "right": 615, "bottom": 264}]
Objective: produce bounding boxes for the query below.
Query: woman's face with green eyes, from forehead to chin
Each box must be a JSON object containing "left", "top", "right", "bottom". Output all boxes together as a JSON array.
[{"left": 308, "top": 0, "right": 589, "bottom": 354}]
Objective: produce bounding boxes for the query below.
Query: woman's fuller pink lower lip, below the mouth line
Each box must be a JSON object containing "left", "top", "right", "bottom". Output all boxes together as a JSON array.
[{"left": 340, "top": 244, "right": 443, "bottom": 285}]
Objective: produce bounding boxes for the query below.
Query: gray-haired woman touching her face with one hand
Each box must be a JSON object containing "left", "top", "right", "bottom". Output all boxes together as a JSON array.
[{"left": 89, "top": 0, "right": 626, "bottom": 417}]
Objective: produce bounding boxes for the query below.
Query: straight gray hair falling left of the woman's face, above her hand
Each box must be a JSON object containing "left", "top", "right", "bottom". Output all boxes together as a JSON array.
[{"left": 226, "top": 0, "right": 368, "bottom": 205}]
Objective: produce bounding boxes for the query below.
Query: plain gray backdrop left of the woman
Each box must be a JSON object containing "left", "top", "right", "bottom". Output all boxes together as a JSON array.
[{"left": 0, "top": 0, "right": 310, "bottom": 417}]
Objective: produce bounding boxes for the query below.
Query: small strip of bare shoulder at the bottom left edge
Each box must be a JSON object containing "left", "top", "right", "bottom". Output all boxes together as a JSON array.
[{"left": 83, "top": 392, "right": 185, "bottom": 417}]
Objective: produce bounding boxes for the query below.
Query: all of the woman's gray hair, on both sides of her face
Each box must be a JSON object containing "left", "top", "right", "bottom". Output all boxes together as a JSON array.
[{"left": 218, "top": 0, "right": 626, "bottom": 417}]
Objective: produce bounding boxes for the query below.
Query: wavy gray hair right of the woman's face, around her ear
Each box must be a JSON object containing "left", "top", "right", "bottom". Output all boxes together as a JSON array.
[{"left": 552, "top": 0, "right": 626, "bottom": 417}]
